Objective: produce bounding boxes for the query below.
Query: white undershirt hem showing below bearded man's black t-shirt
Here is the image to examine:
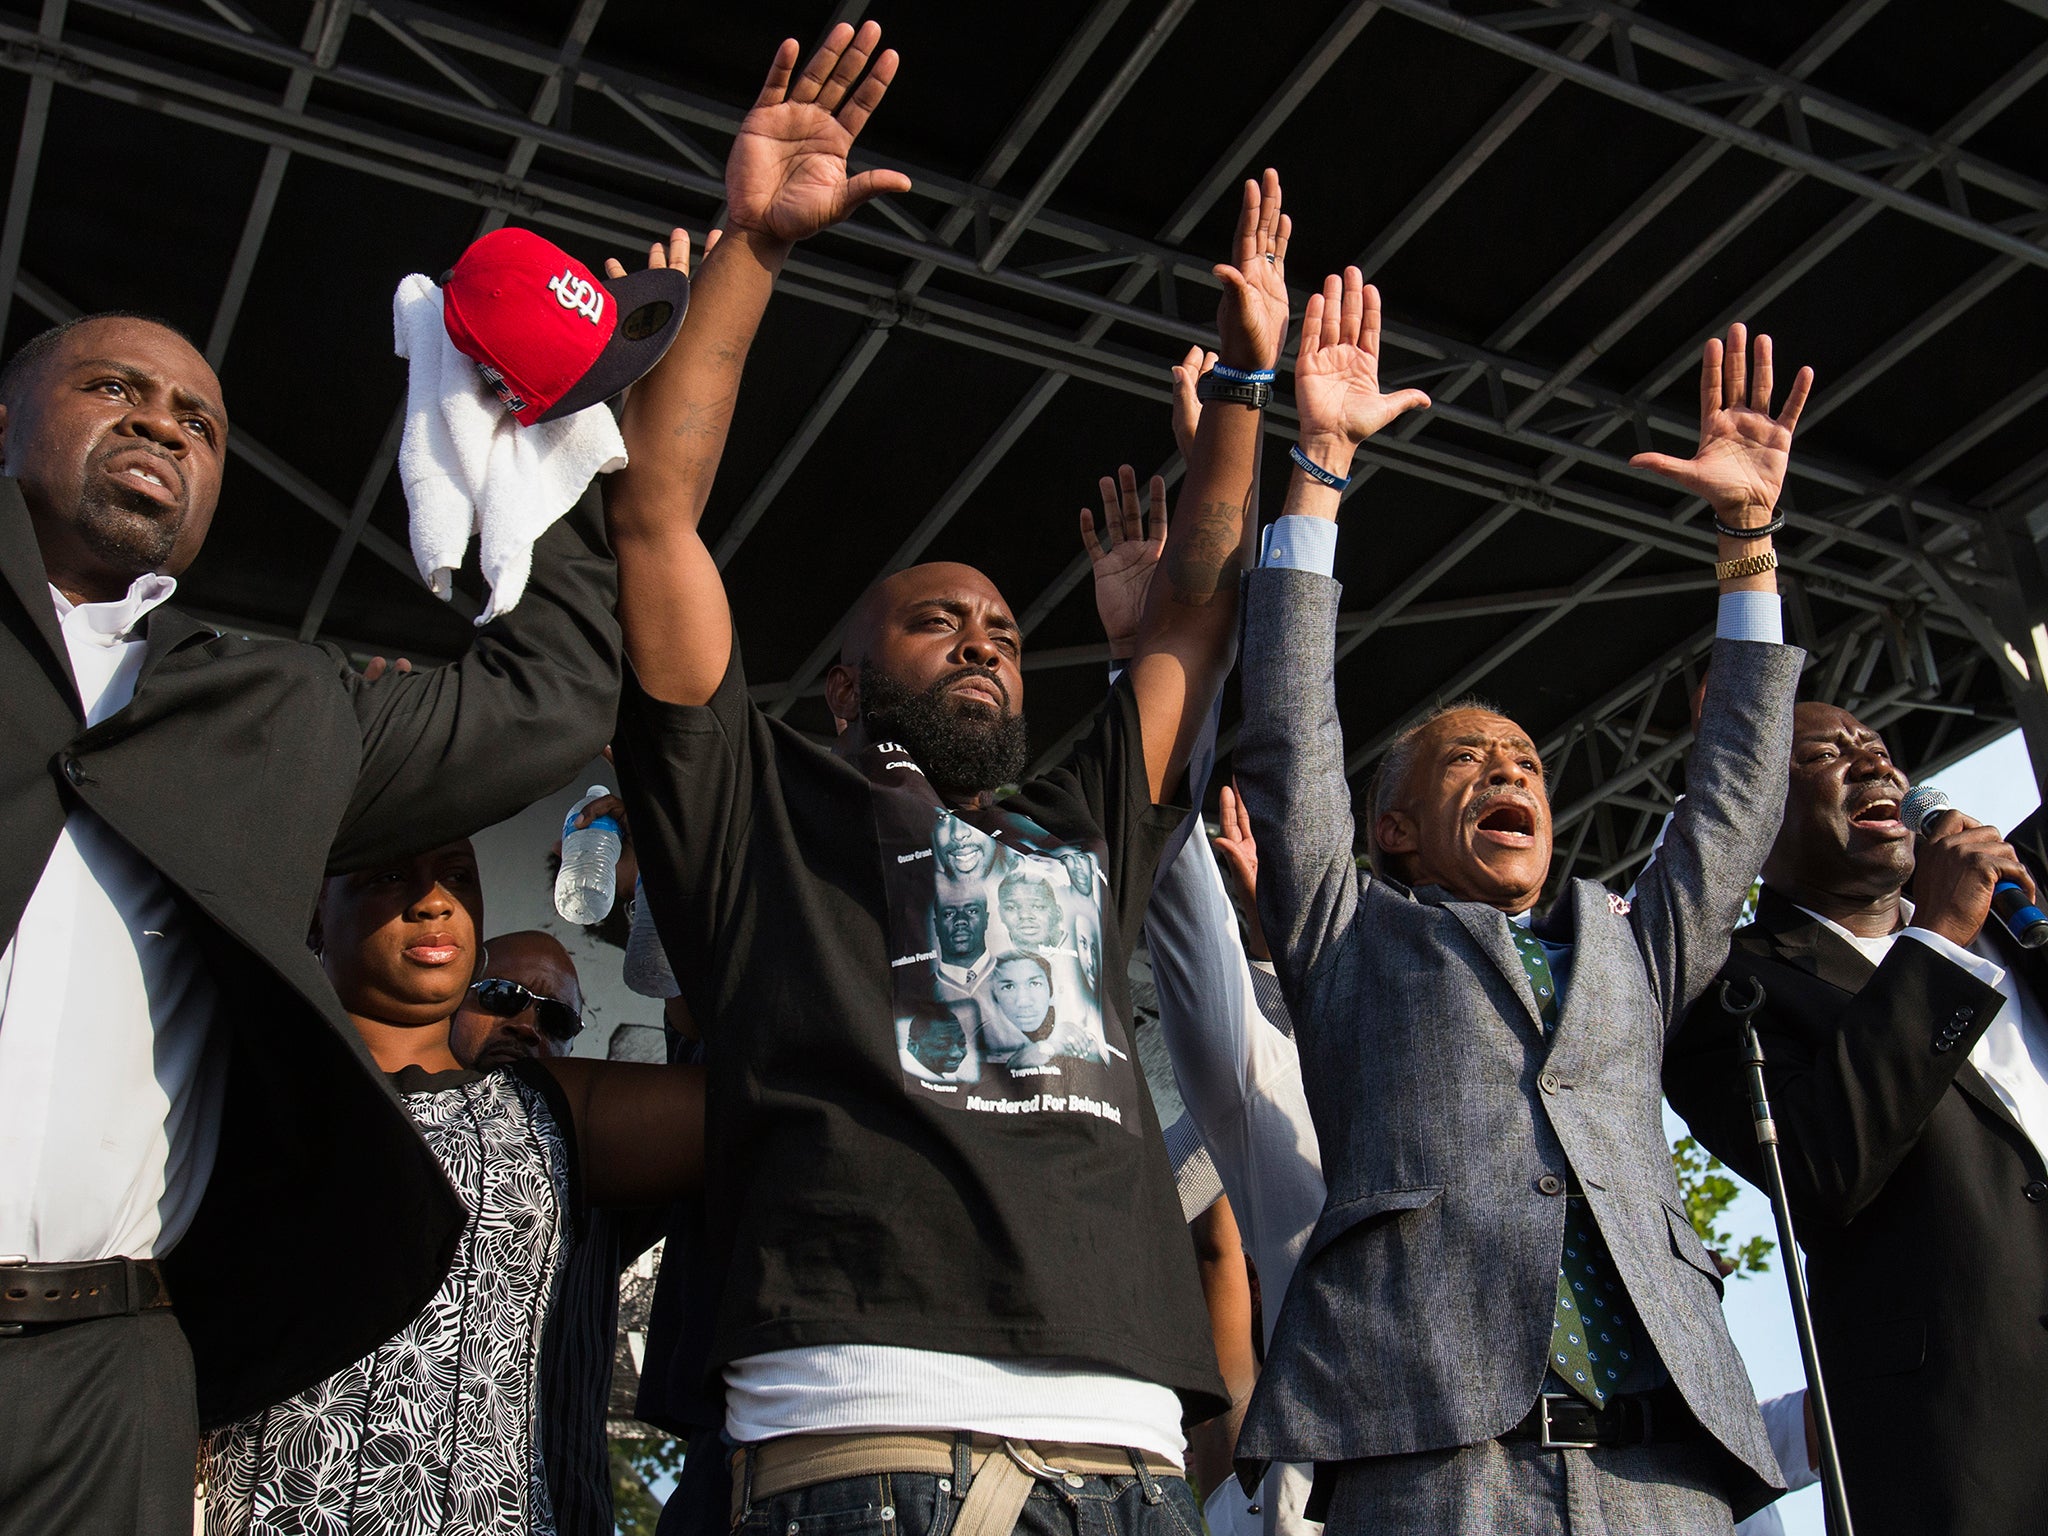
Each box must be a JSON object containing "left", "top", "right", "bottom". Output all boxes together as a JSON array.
[{"left": 725, "top": 1343, "right": 1188, "bottom": 1466}]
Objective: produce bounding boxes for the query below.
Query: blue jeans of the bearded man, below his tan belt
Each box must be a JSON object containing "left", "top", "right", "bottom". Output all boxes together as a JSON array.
[{"left": 733, "top": 1470, "right": 1206, "bottom": 1536}]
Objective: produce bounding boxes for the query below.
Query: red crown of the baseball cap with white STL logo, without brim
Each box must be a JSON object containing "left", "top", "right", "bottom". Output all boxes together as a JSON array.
[{"left": 440, "top": 227, "right": 616, "bottom": 426}]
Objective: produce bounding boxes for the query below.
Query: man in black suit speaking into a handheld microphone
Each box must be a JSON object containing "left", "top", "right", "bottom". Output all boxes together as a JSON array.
[{"left": 1665, "top": 702, "right": 2048, "bottom": 1536}]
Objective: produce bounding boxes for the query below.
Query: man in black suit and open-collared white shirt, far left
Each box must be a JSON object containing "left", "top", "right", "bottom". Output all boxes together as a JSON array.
[{"left": 0, "top": 315, "right": 618, "bottom": 1536}]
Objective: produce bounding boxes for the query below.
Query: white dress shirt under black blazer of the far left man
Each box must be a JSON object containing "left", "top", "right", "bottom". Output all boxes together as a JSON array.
[{"left": 0, "top": 575, "right": 225, "bottom": 1264}]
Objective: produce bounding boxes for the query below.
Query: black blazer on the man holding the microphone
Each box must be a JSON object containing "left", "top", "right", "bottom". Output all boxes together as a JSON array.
[{"left": 1665, "top": 887, "right": 2048, "bottom": 1536}]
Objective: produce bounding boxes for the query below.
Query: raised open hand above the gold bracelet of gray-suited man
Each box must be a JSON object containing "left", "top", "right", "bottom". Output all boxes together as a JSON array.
[{"left": 1628, "top": 322, "right": 1812, "bottom": 526}]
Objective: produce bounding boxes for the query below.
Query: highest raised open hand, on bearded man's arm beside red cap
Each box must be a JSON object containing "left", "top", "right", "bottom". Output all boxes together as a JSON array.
[{"left": 725, "top": 20, "right": 909, "bottom": 242}]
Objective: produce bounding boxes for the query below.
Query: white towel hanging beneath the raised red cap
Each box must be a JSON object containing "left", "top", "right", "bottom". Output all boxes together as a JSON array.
[{"left": 391, "top": 272, "right": 627, "bottom": 625}]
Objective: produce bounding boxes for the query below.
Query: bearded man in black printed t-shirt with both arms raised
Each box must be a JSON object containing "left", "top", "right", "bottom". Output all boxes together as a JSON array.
[{"left": 608, "top": 23, "right": 1288, "bottom": 1536}]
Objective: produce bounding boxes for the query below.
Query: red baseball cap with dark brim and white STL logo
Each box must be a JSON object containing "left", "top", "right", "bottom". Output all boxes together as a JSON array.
[{"left": 440, "top": 229, "right": 690, "bottom": 426}]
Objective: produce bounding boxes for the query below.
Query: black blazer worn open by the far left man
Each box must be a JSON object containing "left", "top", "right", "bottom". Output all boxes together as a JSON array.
[{"left": 0, "top": 479, "right": 621, "bottom": 1425}]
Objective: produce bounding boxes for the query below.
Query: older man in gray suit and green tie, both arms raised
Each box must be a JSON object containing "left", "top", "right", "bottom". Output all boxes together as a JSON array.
[{"left": 1237, "top": 272, "right": 1810, "bottom": 1536}]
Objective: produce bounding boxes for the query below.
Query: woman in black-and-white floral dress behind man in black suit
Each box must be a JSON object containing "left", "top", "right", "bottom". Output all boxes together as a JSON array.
[{"left": 203, "top": 840, "right": 705, "bottom": 1536}]
